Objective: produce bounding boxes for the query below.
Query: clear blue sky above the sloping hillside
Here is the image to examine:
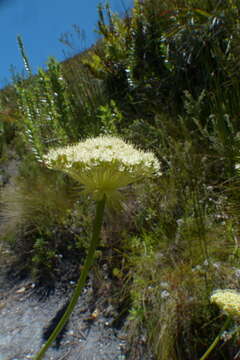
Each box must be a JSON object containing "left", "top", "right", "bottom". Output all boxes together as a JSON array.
[{"left": 0, "top": 0, "right": 133, "bottom": 87}]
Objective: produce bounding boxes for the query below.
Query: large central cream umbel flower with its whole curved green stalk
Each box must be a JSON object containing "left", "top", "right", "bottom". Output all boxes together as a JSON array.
[{"left": 34, "top": 136, "right": 161, "bottom": 360}]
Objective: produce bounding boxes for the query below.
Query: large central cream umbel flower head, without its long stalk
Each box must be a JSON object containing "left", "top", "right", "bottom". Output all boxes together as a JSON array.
[{"left": 44, "top": 136, "right": 161, "bottom": 204}]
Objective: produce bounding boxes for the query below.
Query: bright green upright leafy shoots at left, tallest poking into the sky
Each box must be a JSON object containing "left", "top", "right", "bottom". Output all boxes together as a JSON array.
[{"left": 15, "top": 38, "right": 72, "bottom": 161}]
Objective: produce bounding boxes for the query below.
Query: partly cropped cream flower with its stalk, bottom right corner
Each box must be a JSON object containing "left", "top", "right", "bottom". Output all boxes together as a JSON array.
[{"left": 200, "top": 289, "right": 240, "bottom": 360}]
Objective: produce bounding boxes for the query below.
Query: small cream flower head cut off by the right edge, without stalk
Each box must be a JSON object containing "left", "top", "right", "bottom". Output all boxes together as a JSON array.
[{"left": 210, "top": 289, "right": 240, "bottom": 319}]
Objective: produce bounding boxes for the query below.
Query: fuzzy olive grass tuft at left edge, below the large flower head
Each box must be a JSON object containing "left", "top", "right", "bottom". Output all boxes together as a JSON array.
[{"left": 2, "top": 164, "right": 76, "bottom": 229}]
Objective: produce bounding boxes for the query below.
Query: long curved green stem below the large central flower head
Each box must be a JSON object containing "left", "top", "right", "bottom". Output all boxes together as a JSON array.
[{"left": 34, "top": 196, "right": 106, "bottom": 360}]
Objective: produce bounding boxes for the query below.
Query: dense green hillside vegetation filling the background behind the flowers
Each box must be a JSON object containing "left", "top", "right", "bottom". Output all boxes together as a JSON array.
[{"left": 0, "top": 0, "right": 240, "bottom": 360}]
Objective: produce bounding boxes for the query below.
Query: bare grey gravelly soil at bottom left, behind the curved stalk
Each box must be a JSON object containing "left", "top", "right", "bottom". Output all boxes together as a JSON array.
[{"left": 0, "top": 272, "right": 130, "bottom": 360}]
